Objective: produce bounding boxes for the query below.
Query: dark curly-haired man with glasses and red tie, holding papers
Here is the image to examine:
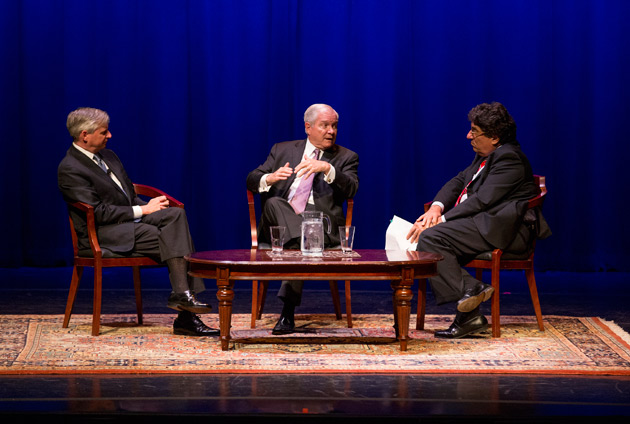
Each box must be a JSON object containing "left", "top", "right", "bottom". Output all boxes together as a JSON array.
[{"left": 407, "top": 102, "right": 550, "bottom": 338}]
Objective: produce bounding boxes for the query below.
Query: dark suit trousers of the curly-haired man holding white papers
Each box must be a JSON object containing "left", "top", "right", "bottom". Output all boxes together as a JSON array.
[{"left": 417, "top": 218, "right": 530, "bottom": 305}]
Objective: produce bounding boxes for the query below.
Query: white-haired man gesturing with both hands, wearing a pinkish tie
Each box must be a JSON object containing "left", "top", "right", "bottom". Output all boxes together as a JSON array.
[{"left": 247, "top": 104, "right": 359, "bottom": 334}]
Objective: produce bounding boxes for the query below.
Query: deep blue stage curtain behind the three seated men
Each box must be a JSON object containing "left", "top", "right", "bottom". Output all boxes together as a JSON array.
[{"left": 0, "top": 0, "right": 630, "bottom": 271}]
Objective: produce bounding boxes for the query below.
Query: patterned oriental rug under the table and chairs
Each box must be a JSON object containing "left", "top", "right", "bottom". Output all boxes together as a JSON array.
[{"left": 0, "top": 314, "right": 630, "bottom": 375}]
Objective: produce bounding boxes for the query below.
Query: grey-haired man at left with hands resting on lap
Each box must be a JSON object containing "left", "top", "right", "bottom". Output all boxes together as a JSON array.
[{"left": 57, "top": 108, "right": 219, "bottom": 336}]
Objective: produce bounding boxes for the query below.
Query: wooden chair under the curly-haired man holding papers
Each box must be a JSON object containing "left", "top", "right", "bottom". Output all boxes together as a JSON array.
[{"left": 416, "top": 175, "right": 547, "bottom": 337}]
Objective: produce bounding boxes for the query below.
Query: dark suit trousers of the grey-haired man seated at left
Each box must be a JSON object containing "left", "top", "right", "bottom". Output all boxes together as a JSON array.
[{"left": 133, "top": 208, "right": 205, "bottom": 293}]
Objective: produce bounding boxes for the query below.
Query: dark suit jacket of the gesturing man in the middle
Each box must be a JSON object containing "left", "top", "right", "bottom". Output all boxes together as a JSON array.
[{"left": 247, "top": 140, "right": 359, "bottom": 244}]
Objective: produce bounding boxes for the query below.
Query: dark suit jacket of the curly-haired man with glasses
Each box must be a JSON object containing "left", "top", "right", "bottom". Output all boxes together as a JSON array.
[{"left": 434, "top": 144, "right": 548, "bottom": 249}]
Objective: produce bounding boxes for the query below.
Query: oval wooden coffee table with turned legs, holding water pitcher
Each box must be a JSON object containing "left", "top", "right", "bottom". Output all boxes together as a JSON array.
[{"left": 186, "top": 249, "right": 442, "bottom": 351}]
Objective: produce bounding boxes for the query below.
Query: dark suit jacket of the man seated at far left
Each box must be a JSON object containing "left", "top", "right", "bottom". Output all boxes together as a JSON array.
[{"left": 57, "top": 146, "right": 146, "bottom": 252}]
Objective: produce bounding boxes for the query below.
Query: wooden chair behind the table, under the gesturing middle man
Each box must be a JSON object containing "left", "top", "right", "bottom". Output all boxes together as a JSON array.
[{"left": 247, "top": 190, "right": 354, "bottom": 328}]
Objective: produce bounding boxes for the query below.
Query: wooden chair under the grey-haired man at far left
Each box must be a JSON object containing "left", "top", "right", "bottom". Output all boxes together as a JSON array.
[{"left": 63, "top": 184, "right": 184, "bottom": 336}]
